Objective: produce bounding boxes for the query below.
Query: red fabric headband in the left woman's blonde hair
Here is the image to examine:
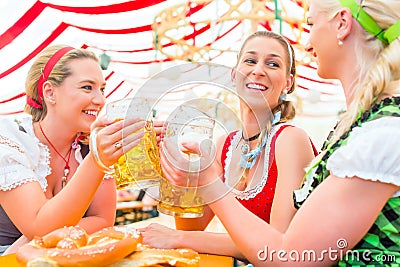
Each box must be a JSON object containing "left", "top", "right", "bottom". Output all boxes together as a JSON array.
[{"left": 26, "top": 46, "right": 74, "bottom": 109}]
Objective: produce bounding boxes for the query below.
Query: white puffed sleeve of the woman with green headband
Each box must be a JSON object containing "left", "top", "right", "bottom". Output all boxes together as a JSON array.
[{"left": 327, "top": 117, "right": 400, "bottom": 189}]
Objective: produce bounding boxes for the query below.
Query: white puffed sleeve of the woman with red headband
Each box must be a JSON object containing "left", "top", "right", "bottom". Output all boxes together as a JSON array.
[{"left": 0, "top": 118, "right": 50, "bottom": 191}]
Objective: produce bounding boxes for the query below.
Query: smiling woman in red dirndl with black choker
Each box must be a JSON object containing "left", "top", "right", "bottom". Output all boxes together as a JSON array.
[{"left": 141, "top": 31, "right": 315, "bottom": 259}]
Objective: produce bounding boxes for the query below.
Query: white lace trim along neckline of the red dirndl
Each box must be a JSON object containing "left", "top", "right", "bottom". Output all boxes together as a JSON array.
[{"left": 224, "top": 123, "right": 287, "bottom": 200}]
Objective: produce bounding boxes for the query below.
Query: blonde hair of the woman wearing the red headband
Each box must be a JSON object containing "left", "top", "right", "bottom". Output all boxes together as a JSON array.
[{"left": 25, "top": 45, "right": 99, "bottom": 122}]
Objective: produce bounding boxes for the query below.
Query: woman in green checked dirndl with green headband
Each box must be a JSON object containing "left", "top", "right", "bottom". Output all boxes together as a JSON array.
[{"left": 161, "top": 0, "right": 400, "bottom": 266}]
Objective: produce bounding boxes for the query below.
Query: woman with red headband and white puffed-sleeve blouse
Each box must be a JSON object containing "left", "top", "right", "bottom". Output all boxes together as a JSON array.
[{"left": 0, "top": 45, "right": 143, "bottom": 254}]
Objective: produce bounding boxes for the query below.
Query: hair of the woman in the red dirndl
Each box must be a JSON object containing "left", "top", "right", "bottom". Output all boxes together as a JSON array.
[{"left": 234, "top": 31, "right": 296, "bottom": 122}]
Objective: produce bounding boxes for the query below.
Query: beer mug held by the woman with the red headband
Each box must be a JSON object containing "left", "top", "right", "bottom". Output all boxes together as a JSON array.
[{"left": 90, "top": 98, "right": 161, "bottom": 190}]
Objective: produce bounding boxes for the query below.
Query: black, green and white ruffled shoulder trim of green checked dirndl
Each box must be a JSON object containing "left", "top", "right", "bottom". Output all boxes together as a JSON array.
[{"left": 294, "top": 97, "right": 400, "bottom": 208}]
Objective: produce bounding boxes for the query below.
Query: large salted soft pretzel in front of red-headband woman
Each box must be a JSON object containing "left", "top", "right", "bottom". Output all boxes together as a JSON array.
[{"left": 17, "top": 226, "right": 141, "bottom": 267}]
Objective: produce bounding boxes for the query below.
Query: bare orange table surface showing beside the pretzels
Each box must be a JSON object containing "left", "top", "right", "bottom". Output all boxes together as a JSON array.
[{"left": 0, "top": 254, "right": 233, "bottom": 267}]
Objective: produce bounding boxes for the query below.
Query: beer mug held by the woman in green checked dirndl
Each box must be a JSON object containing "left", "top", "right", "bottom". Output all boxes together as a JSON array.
[{"left": 157, "top": 106, "right": 215, "bottom": 218}]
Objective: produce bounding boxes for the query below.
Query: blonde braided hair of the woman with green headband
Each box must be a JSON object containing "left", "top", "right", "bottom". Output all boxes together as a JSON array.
[{"left": 310, "top": 0, "right": 400, "bottom": 144}]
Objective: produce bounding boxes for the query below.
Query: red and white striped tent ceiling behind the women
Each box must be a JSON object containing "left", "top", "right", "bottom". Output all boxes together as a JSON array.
[{"left": 0, "top": 0, "right": 345, "bottom": 147}]
